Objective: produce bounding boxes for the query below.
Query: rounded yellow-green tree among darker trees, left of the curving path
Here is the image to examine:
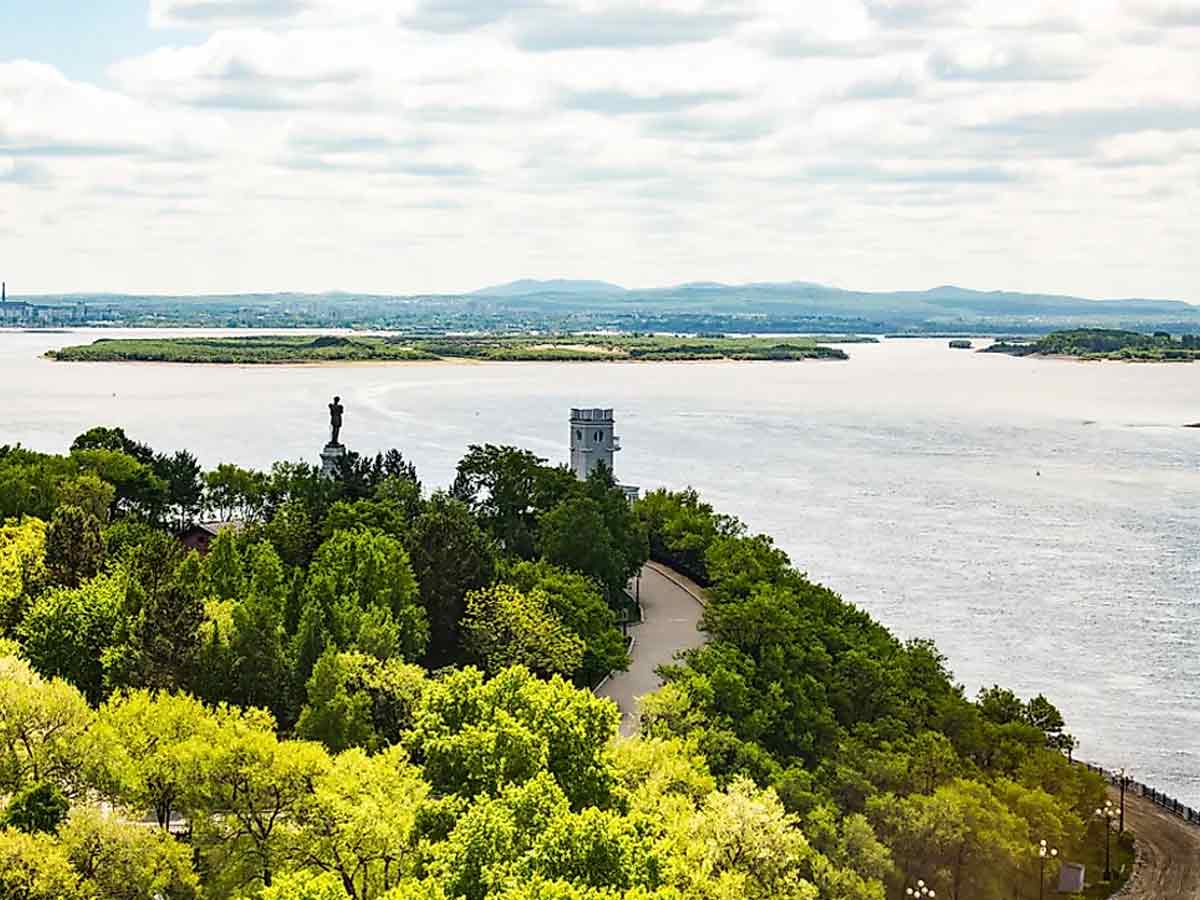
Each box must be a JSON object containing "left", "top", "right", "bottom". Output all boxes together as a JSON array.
[{"left": 461, "top": 584, "right": 583, "bottom": 677}]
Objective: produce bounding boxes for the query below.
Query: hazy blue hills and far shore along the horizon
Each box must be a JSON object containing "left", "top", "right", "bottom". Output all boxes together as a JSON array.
[{"left": 10, "top": 278, "right": 1200, "bottom": 334}]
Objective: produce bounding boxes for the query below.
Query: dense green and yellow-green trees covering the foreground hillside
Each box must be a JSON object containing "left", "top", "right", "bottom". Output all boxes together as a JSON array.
[{"left": 0, "top": 428, "right": 1123, "bottom": 900}]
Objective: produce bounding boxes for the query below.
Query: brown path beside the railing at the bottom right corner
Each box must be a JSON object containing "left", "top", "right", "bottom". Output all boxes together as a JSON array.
[{"left": 1109, "top": 788, "right": 1200, "bottom": 900}]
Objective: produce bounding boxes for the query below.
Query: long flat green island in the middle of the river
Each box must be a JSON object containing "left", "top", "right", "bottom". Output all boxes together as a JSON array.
[{"left": 47, "top": 334, "right": 875, "bottom": 365}]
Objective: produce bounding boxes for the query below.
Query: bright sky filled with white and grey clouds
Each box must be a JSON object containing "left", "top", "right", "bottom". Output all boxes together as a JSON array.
[{"left": 0, "top": 0, "right": 1200, "bottom": 301}]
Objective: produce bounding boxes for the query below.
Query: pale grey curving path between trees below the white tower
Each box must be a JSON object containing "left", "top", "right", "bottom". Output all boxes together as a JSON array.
[{"left": 596, "top": 563, "right": 704, "bottom": 736}]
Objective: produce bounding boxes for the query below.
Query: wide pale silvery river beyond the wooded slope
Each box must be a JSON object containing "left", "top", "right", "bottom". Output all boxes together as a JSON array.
[{"left": 0, "top": 331, "right": 1200, "bottom": 805}]
